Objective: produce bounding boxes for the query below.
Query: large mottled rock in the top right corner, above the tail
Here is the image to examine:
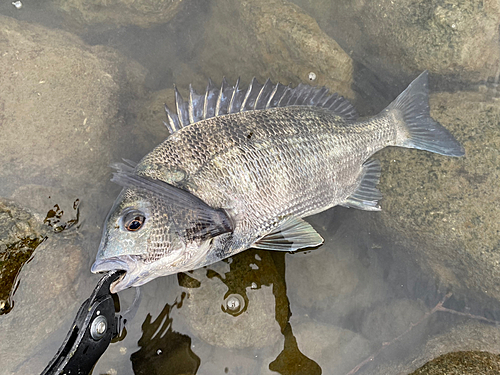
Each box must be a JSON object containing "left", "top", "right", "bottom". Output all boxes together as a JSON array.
[{"left": 293, "top": 0, "right": 500, "bottom": 81}]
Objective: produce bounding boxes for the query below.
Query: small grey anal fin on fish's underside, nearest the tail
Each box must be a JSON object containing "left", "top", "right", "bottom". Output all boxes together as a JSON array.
[{"left": 340, "top": 159, "right": 382, "bottom": 211}]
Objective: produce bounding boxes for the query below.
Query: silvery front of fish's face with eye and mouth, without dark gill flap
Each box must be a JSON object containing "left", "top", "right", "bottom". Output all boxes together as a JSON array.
[{"left": 91, "top": 189, "right": 185, "bottom": 293}]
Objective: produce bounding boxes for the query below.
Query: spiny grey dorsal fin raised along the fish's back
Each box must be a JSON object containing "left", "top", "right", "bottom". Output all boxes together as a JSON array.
[{"left": 165, "top": 77, "right": 357, "bottom": 134}]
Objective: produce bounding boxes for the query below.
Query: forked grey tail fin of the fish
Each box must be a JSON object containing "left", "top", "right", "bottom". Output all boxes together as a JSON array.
[{"left": 386, "top": 70, "right": 465, "bottom": 156}]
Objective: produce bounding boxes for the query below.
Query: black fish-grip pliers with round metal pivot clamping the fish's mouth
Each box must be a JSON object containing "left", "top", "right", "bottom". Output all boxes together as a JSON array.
[{"left": 41, "top": 270, "right": 125, "bottom": 375}]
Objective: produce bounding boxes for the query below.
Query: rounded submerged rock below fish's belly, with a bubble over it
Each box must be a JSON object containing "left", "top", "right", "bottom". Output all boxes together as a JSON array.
[{"left": 179, "top": 250, "right": 288, "bottom": 349}]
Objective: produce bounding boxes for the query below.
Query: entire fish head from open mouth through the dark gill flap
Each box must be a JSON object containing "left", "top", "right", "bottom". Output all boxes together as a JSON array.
[{"left": 91, "top": 166, "right": 232, "bottom": 293}]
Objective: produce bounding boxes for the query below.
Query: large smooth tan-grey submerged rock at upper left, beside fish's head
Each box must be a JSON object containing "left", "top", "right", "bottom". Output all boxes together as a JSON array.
[{"left": 0, "top": 16, "right": 144, "bottom": 203}]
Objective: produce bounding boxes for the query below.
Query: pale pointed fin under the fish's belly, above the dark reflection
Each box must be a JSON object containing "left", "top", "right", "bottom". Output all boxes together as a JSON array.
[{"left": 251, "top": 217, "right": 324, "bottom": 251}]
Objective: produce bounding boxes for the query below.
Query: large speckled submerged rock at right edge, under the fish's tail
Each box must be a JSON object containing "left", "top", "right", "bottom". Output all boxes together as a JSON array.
[{"left": 375, "top": 92, "right": 500, "bottom": 308}]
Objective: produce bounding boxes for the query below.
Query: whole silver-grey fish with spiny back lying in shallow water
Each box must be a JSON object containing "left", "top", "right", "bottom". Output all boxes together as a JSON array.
[{"left": 91, "top": 71, "right": 465, "bottom": 293}]
